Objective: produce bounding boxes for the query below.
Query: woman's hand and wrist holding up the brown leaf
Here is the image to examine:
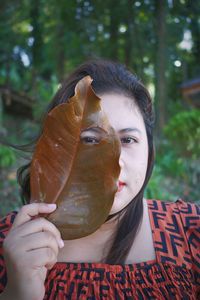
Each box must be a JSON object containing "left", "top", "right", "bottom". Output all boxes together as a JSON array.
[{"left": 3, "top": 203, "right": 64, "bottom": 300}]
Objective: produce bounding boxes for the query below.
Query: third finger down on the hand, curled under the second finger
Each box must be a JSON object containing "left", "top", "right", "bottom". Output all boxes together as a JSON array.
[{"left": 20, "top": 231, "right": 58, "bottom": 256}]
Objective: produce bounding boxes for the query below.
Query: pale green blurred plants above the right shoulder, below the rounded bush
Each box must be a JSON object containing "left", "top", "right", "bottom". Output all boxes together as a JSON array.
[{"left": 145, "top": 132, "right": 200, "bottom": 201}]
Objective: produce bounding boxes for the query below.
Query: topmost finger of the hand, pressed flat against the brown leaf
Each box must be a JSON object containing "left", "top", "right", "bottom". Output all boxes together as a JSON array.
[{"left": 12, "top": 203, "right": 56, "bottom": 228}]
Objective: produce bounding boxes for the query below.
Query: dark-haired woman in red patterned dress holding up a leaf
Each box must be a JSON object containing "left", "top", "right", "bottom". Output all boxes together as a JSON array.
[{"left": 0, "top": 60, "right": 200, "bottom": 300}]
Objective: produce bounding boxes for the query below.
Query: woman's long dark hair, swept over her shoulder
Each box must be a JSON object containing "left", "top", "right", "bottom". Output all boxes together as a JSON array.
[{"left": 17, "top": 59, "right": 154, "bottom": 264}]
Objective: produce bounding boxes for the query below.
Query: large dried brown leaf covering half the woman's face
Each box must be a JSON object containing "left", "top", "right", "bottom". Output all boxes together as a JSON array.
[{"left": 31, "top": 76, "right": 120, "bottom": 240}]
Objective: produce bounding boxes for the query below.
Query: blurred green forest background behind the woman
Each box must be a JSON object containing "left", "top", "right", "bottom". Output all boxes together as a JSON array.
[{"left": 0, "top": 0, "right": 200, "bottom": 216}]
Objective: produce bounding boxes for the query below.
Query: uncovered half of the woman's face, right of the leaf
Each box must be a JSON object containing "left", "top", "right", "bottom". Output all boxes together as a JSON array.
[{"left": 100, "top": 93, "right": 148, "bottom": 214}]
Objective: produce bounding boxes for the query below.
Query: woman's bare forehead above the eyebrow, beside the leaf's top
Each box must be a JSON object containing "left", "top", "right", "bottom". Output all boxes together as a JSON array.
[{"left": 100, "top": 94, "right": 144, "bottom": 130}]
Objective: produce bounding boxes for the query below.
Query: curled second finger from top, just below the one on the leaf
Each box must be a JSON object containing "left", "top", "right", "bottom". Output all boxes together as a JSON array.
[{"left": 12, "top": 218, "right": 64, "bottom": 248}]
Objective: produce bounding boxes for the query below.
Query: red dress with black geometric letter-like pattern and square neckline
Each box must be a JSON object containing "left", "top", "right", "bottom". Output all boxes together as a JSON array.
[{"left": 0, "top": 200, "right": 200, "bottom": 300}]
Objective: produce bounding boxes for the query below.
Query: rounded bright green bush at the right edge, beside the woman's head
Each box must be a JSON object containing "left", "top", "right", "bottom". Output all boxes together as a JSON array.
[{"left": 164, "top": 109, "right": 200, "bottom": 159}]
